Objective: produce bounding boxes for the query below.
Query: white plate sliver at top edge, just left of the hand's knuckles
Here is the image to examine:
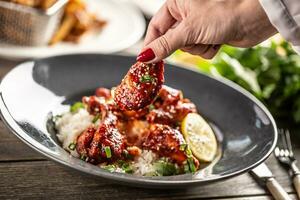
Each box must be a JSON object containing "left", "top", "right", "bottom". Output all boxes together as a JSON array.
[{"left": 131, "top": 0, "right": 165, "bottom": 17}]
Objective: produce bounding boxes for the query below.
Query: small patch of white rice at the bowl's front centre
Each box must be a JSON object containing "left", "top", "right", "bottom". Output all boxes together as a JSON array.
[{"left": 133, "top": 150, "right": 157, "bottom": 176}]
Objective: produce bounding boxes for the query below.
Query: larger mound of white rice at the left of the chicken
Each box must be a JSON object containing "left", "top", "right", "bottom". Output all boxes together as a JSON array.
[{"left": 55, "top": 108, "right": 94, "bottom": 157}]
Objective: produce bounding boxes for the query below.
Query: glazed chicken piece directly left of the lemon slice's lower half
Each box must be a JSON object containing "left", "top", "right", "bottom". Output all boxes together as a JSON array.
[{"left": 142, "top": 124, "right": 187, "bottom": 164}]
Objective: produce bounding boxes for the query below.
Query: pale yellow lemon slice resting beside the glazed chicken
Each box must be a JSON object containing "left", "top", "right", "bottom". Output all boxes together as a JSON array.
[{"left": 181, "top": 113, "right": 218, "bottom": 162}]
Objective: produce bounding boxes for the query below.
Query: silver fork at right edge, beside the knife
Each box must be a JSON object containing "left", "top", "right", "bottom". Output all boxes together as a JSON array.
[{"left": 274, "top": 129, "right": 300, "bottom": 198}]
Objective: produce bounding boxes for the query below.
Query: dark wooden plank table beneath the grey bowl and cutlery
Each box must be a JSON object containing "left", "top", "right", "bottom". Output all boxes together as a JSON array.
[{"left": 0, "top": 59, "right": 300, "bottom": 200}]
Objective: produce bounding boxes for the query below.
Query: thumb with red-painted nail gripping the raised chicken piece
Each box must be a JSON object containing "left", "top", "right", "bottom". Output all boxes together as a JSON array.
[{"left": 137, "top": 23, "right": 188, "bottom": 63}]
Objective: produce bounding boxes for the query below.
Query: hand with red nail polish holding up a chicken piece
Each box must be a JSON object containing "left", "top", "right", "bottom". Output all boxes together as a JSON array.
[{"left": 137, "top": 0, "right": 276, "bottom": 63}]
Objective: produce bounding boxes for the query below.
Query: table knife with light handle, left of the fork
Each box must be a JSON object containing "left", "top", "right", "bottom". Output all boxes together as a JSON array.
[{"left": 250, "top": 163, "right": 291, "bottom": 200}]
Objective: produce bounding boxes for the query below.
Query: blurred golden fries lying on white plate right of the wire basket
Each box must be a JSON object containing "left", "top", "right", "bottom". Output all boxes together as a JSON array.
[{"left": 50, "top": 0, "right": 106, "bottom": 45}]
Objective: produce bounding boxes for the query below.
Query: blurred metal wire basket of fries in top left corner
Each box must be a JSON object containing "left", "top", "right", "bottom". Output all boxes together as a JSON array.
[{"left": 0, "top": 0, "right": 68, "bottom": 46}]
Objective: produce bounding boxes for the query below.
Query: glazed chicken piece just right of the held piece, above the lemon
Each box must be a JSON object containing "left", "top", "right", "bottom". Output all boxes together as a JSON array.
[{"left": 147, "top": 85, "right": 197, "bottom": 125}]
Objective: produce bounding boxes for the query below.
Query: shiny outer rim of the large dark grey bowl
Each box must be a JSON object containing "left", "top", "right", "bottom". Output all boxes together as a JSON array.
[{"left": 0, "top": 53, "right": 278, "bottom": 187}]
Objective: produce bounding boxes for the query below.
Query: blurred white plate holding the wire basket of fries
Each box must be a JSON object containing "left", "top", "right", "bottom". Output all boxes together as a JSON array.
[{"left": 0, "top": 0, "right": 146, "bottom": 59}]
